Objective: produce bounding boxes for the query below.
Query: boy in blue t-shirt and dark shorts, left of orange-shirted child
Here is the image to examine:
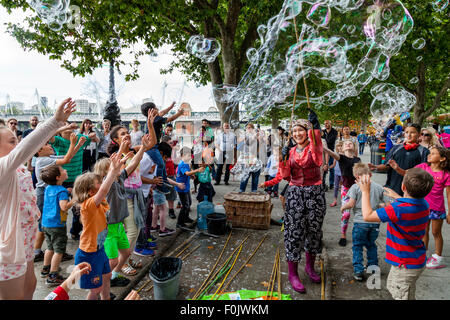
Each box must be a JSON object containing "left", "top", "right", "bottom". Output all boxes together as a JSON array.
[{"left": 41, "top": 164, "right": 74, "bottom": 287}]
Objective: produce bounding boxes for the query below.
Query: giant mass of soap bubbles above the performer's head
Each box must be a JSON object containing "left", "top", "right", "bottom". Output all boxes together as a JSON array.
[{"left": 208, "top": 0, "right": 414, "bottom": 121}]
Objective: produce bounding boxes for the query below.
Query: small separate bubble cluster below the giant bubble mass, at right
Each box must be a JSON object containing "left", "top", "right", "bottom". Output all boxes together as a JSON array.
[{"left": 370, "top": 84, "right": 418, "bottom": 129}]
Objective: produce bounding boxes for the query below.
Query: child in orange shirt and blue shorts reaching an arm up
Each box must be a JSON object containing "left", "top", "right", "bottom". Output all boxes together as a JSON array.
[{"left": 73, "top": 153, "right": 122, "bottom": 300}]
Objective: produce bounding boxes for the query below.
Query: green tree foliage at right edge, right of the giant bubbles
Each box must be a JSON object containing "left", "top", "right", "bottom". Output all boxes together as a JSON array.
[{"left": 388, "top": 0, "right": 450, "bottom": 124}]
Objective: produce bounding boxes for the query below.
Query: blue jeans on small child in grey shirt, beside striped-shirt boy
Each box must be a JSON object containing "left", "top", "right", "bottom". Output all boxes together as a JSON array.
[{"left": 352, "top": 222, "right": 380, "bottom": 273}]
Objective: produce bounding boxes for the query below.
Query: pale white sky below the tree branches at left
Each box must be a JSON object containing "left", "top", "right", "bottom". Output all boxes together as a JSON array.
[{"left": 0, "top": 6, "right": 215, "bottom": 111}]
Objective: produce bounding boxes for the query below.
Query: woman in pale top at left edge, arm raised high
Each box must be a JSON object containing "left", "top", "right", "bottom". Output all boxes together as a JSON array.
[{"left": 0, "top": 98, "right": 76, "bottom": 300}]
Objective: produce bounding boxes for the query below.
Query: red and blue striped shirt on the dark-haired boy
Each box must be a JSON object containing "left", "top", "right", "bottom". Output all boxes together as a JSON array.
[{"left": 377, "top": 198, "right": 430, "bottom": 269}]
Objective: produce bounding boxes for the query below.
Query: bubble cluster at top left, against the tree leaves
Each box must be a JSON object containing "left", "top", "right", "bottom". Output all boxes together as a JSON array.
[{"left": 28, "top": 0, "right": 72, "bottom": 31}]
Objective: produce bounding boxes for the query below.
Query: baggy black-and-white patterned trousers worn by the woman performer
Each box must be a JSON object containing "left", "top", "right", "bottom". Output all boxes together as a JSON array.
[{"left": 284, "top": 185, "right": 326, "bottom": 262}]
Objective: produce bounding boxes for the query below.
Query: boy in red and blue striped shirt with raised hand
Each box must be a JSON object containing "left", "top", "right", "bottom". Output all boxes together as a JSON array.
[{"left": 358, "top": 168, "right": 434, "bottom": 300}]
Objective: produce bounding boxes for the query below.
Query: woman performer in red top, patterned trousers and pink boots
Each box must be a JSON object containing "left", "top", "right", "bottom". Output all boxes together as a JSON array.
[{"left": 280, "top": 110, "right": 326, "bottom": 293}]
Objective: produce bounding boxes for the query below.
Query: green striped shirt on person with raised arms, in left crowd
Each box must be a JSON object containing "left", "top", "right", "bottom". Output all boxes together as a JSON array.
[{"left": 52, "top": 133, "right": 91, "bottom": 182}]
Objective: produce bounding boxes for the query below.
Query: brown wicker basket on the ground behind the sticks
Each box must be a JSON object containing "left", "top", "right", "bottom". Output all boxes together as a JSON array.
[{"left": 224, "top": 192, "right": 273, "bottom": 230}]
